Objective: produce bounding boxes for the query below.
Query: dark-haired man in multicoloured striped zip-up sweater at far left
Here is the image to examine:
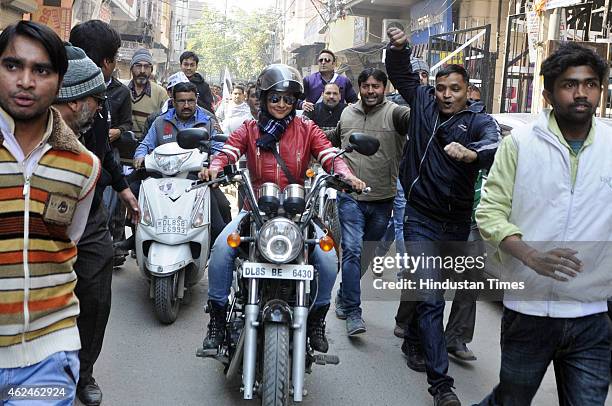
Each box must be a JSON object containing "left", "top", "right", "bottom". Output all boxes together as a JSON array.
[{"left": 0, "top": 21, "right": 104, "bottom": 406}]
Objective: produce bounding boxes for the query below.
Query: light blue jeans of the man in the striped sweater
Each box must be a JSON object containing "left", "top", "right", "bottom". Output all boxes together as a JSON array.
[{"left": 0, "top": 351, "right": 79, "bottom": 406}]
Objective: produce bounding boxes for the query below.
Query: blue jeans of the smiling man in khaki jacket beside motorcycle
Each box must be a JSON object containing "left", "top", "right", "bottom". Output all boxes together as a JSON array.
[{"left": 338, "top": 193, "right": 393, "bottom": 316}]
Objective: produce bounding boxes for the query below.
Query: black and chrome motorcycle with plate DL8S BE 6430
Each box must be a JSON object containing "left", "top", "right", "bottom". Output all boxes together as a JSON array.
[{"left": 178, "top": 134, "right": 379, "bottom": 406}]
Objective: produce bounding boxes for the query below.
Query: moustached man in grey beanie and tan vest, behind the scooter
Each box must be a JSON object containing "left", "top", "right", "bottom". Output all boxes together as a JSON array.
[{"left": 128, "top": 48, "right": 168, "bottom": 141}]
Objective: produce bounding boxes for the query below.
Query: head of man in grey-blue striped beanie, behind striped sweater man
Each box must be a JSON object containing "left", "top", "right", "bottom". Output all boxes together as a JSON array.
[{"left": 55, "top": 45, "right": 106, "bottom": 136}]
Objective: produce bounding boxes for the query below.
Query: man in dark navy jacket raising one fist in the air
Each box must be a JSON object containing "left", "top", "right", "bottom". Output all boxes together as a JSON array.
[{"left": 385, "top": 28, "right": 500, "bottom": 406}]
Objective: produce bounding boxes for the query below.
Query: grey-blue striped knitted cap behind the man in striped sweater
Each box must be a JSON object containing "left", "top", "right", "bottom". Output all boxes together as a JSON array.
[{"left": 57, "top": 42, "right": 106, "bottom": 103}]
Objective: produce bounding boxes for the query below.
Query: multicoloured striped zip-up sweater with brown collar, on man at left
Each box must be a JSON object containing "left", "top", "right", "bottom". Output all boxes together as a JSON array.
[{"left": 0, "top": 110, "right": 100, "bottom": 368}]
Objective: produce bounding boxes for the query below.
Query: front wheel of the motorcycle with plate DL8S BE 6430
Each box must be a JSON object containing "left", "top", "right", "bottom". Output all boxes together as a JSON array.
[{"left": 261, "top": 323, "right": 290, "bottom": 406}]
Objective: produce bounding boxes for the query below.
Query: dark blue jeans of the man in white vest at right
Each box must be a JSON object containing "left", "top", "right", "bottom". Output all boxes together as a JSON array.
[{"left": 480, "top": 308, "right": 610, "bottom": 406}]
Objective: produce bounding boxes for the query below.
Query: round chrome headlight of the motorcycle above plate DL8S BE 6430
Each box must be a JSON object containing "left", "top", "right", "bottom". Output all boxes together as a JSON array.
[{"left": 257, "top": 217, "right": 304, "bottom": 264}]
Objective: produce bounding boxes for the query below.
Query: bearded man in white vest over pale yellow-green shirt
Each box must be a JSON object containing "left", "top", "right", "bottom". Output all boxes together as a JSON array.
[{"left": 476, "top": 42, "right": 612, "bottom": 406}]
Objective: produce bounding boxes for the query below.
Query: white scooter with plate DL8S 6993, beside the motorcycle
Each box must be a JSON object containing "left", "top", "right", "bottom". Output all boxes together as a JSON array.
[{"left": 136, "top": 129, "right": 222, "bottom": 324}]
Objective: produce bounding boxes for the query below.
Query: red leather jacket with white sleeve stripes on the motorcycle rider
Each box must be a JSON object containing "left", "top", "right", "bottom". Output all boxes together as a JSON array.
[{"left": 210, "top": 117, "right": 352, "bottom": 191}]
